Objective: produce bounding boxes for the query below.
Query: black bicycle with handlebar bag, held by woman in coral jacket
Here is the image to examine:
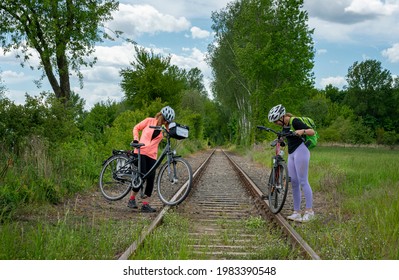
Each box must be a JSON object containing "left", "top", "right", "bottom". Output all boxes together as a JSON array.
[{"left": 100, "top": 123, "right": 193, "bottom": 206}]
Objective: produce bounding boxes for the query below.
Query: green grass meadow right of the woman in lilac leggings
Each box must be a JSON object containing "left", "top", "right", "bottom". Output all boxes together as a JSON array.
[{"left": 247, "top": 147, "right": 399, "bottom": 260}]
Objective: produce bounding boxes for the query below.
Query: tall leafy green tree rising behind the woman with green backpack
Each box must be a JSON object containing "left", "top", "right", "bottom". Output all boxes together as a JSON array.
[{"left": 208, "top": 0, "right": 314, "bottom": 145}]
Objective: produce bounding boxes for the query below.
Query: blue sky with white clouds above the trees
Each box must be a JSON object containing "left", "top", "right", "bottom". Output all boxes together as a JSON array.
[{"left": 0, "top": 0, "right": 399, "bottom": 109}]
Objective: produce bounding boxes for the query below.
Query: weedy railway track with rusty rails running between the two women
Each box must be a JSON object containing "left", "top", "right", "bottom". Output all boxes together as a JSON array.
[{"left": 119, "top": 150, "right": 319, "bottom": 260}]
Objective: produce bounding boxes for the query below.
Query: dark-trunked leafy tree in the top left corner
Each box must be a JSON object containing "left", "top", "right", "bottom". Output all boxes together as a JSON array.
[{"left": 0, "top": 0, "right": 119, "bottom": 103}]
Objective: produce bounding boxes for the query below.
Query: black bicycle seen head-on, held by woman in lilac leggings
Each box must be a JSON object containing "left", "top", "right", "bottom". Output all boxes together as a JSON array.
[{"left": 257, "top": 126, "right": 294, "bottom": 214}]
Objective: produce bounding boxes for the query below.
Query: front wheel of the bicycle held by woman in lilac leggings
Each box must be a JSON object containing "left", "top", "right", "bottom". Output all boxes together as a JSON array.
[{"left": 268, "top": 162, "right": 289, "bottom": 214}]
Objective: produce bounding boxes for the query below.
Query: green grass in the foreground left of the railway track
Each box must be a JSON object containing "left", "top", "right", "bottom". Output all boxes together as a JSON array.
[{"left": 0, "top": 208, "right": 145, "bottom": 260}]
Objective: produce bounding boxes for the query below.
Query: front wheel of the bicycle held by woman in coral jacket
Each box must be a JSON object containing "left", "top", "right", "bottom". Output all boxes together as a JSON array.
[{"left": 157, "top": 158, "right": 193, "bottom": 206}]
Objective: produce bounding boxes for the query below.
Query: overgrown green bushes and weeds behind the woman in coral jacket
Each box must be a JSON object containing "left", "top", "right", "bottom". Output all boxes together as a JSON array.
[{"left": 0, "top": 94, "right": 208, "bottom": 220}]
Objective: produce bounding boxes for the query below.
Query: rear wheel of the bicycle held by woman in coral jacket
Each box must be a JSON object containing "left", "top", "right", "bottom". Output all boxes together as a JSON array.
[{"left": 100, "top": 154, "right": 133, "bottom": 200}]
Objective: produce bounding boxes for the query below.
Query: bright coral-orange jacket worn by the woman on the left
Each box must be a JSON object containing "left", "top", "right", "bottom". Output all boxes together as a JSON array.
[{"left": 133, "top": 118, "right": 163, "bottom": 159}]
